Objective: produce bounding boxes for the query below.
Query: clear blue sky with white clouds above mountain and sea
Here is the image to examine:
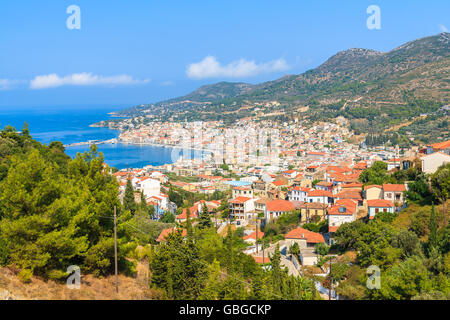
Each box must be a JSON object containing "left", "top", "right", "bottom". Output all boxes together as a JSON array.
[{"left": 0, "top": 0, "right": 450, "bottom": 109}]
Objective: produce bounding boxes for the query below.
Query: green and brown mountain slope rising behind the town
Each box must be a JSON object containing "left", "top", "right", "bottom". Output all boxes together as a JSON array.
[{"left": 110, "top": 32, "right": 450, "bottom": 142}]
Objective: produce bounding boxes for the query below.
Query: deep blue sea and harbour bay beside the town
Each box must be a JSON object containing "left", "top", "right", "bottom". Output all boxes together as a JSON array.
[{"left": 0, "top": 106, "right": 197, "bottom": 169}]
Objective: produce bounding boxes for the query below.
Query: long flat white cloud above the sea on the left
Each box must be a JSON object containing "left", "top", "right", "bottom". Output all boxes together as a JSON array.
[{"left": 30, "top": 72, "right": 150, "bottom": 89}]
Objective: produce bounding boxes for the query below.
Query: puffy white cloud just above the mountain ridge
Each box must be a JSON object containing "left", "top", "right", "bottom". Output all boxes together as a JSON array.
[{"left": 186, "top": 56, "right": 289, "bottom": 79}]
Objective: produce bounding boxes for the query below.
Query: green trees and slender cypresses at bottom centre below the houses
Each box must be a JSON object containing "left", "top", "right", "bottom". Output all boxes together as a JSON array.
[{"left": 150, "top": 212, "right": 318, "bottom": 300}]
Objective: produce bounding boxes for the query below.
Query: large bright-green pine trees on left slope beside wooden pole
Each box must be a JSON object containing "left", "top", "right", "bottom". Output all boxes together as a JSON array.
[{"left": 0, "top": 127, "right": 143, "bottom": 281}]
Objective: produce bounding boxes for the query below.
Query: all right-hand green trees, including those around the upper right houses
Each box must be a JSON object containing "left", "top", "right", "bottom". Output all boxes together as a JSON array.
[{"left": 333, "top": 162, "right": 450, "bottom": 299}]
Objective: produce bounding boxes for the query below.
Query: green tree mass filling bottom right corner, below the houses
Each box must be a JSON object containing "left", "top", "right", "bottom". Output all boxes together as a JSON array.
[{"left": 333, "top": 205, "right": 450, "bottom": 300}]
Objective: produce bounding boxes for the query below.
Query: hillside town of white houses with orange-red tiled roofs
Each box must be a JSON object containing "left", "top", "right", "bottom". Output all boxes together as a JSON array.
[{"left": 113, "top": 119, "right": 450, "bottom": 297}]
